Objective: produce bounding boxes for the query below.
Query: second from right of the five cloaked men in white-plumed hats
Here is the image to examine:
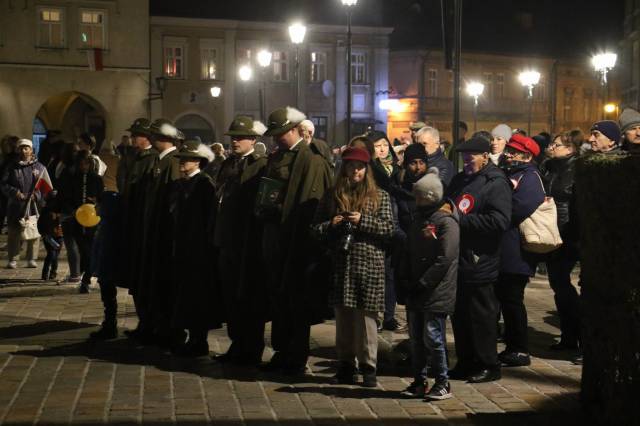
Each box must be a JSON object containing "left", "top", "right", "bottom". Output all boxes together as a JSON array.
[{"left": 215, "top": 115, "right": 269, "bottom": 365}]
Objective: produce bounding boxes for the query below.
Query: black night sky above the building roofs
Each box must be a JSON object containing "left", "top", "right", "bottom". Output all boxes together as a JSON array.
[{"left": 150, "top": 0, "right": 624, "bottom": 57}]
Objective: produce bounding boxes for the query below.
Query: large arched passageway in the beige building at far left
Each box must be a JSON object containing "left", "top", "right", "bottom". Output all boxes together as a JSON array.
[{"left": 34, "top": 92, "right": 106, "bottom": 149}]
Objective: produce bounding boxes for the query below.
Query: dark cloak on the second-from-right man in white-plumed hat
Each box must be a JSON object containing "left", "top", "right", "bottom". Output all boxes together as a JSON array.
[{"left": 214, "top": 152, "right": 269, "bottom": 319}]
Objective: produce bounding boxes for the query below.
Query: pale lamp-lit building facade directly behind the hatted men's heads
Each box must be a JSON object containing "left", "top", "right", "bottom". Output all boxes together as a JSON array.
[{"left": 151, "top": 16, "right": 391, "bottom": 144}]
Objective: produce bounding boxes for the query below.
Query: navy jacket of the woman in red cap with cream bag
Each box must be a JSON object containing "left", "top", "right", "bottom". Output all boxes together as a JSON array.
[{"left": 500, "top": 163, "right": 545, "bottom": 277}]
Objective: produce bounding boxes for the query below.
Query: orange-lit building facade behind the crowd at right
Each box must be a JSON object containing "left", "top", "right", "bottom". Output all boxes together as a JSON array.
[{"left": 388, "top": 50, "right": 616, "bottom": 140}]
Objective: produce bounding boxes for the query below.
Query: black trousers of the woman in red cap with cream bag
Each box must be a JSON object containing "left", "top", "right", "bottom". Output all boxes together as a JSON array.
[{"left": 496, "top": 274, "right": 529, "bottom": 354}]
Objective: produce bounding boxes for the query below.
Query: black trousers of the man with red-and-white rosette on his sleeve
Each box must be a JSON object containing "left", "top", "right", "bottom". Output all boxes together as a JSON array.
[{"left": 452, "top": 282, "right": 499, "bottom": 371}]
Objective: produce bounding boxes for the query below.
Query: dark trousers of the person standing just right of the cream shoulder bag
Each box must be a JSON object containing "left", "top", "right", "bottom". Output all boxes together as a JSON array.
[{"left": 547, "top": 256, "right": 580, "bottom": 345}]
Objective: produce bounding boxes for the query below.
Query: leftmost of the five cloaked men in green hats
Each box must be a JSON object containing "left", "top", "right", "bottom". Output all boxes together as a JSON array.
[{"left": 121, "top": 118, "right": 158, "bottom": 342}]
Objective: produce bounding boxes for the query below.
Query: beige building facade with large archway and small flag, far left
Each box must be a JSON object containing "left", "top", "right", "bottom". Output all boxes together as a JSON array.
[{"left": 0, "top": 0, "right": 149, "bottom": 149}]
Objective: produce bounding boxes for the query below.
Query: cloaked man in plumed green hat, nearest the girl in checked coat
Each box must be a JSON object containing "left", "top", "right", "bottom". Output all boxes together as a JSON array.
[{"left": 258, "top": 107, "right": 331, "bottom": 375}]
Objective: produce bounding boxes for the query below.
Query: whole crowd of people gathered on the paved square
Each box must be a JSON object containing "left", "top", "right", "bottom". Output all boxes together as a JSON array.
[{"left": 0, "top": 107, "right": 640, "bottom": 400}]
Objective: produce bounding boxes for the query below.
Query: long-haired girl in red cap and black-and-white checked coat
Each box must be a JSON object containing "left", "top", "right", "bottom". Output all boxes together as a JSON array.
[{"left": 314, "top": 148, "right": 394, "bottom": 387}]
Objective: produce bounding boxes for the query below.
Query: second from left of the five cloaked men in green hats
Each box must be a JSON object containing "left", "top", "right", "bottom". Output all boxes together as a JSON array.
[{"left": 138, "top": 118, "right": 184, "bottom": 348}]
